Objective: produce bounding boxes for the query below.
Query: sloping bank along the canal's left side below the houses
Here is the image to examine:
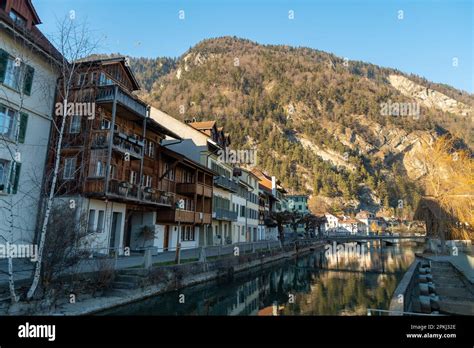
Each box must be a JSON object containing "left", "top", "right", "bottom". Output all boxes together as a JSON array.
[{"left": 10, "top": 242, "right": 324, "bottom": 315}]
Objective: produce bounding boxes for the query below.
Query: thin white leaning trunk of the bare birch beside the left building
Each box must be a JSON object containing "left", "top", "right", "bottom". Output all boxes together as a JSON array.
[{"left": 26, "top": 97, "right": 67, "bottom": 300}]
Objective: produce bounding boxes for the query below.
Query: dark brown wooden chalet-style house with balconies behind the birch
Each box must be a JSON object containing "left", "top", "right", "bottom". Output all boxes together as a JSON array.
[{"left": 49, "top": 57, "right": 213, "bottom": 254}]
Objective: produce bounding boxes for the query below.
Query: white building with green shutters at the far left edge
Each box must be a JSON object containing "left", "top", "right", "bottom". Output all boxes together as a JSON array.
[{"left": 0, "top": 0, "right": 62, "bottom": 243}]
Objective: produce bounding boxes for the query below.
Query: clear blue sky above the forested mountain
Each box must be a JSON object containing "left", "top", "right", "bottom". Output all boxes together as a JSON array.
[{"left": 33, "top": 0, "right": 474, "bottom": 93}]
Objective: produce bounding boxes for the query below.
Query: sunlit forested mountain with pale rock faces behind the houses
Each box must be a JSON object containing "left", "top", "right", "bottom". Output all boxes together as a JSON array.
[{"left": 131, "top": 37, "right": 474, "bottom": 213}]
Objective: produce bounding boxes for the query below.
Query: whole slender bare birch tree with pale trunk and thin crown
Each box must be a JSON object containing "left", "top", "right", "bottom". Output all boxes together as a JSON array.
[{"left": 27, "top": 13, "right": 98, "bottom": 299}]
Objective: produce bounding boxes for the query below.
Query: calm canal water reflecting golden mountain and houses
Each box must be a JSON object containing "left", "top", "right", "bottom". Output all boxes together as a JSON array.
[{"left": 100, "top": 242, "right": 421, "bottom": 315}]
